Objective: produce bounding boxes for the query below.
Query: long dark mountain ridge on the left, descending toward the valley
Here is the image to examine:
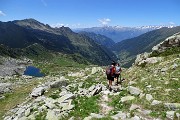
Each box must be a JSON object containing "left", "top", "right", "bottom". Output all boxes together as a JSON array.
[{"left": 0, "top": 19, "right": 116, "bottom": 64}]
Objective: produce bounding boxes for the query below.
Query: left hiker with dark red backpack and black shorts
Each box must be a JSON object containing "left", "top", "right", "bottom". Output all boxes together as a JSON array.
[{"left": 106, "top": 62, "right": 116, "bottom": 90}]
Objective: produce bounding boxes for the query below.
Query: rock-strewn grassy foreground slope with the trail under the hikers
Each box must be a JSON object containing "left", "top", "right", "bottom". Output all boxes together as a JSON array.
[{"left": 0, "top": 33, "right": 180, "bottom": 120}]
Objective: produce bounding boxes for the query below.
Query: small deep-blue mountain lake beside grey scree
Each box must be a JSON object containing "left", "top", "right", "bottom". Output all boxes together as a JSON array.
[{"left": 24, "top": 66, "right": 45, "bottom": 77}]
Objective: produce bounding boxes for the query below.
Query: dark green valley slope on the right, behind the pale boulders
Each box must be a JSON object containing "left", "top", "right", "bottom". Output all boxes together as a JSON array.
[{"left": 112, "top": 26, "right": 180, "bottom": 67}]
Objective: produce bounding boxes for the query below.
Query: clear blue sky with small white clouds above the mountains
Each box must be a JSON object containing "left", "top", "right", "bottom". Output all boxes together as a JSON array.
[{"left": 0, "top": 0, "right": 180, "bottom": 28}]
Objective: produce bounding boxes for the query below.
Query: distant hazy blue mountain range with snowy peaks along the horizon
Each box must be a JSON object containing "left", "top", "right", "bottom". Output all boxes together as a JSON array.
[{"left": 75, "top": 25, "right": 175, "bottom": 42}]
